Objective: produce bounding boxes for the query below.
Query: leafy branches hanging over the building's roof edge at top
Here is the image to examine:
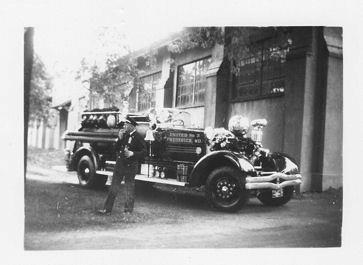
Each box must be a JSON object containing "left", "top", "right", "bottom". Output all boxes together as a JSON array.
[{"left": 168, "top": 27, "right": 292, "bottom": 74}]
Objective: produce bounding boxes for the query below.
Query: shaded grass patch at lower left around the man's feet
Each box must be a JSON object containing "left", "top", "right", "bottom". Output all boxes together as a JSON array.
[{"left": 25, "top": 177, "right": 150, "bottom": 232}]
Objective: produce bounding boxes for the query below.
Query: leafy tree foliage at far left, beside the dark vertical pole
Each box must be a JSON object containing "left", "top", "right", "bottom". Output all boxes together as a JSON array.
[{"left": 29, "top": 54, "right": 52, "bottom": 124}]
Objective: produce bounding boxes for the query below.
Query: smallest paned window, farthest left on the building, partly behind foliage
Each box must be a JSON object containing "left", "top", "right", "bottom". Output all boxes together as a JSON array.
[{"left": 137, "top": 72, "right": 161, "bottom": 111}]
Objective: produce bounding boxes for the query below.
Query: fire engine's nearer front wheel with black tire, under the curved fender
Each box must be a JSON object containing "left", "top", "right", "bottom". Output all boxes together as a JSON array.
[{"left": 205, "top": 167, "right": 248, "bottom": 212}]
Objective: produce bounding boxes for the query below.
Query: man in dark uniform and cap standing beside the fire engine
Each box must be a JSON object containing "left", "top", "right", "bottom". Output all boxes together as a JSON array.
[{"left": 98, "top": 118, "right": 147, "bottom": 215}]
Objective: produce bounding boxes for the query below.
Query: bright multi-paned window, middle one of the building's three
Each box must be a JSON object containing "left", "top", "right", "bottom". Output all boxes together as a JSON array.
[{"left": 175, "top": 58, "right": 212, "bottom": 107}]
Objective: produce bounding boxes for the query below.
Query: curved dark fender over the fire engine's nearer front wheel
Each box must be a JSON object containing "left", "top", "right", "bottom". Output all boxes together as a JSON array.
[{"left": 189, "top": 150, "right": 255, "bottom": 187}]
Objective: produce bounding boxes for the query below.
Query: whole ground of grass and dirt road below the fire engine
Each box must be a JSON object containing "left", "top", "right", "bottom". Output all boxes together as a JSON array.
[{"left": 24, "top": 166, "right": 342, "bottom": 250}]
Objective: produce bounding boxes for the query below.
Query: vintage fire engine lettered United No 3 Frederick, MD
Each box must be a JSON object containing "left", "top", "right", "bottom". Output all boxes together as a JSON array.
[{"left": 64, "top": 106, "right": 301, "bottom": 211}]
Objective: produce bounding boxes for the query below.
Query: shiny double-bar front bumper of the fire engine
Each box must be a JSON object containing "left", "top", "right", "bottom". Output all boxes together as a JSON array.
[{"left": 245, "top": 172, "right": 302, "bottom": 190}]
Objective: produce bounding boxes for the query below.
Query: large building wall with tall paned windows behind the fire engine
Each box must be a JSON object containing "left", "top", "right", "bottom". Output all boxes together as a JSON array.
[{"left": 129, "top": 27, "right": 343, "bottom": 191}]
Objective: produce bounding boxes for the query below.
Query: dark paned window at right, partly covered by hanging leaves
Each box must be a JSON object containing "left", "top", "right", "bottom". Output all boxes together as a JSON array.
[{"left": 232, "top": 39, "right": 286, "bottom": 100}]
